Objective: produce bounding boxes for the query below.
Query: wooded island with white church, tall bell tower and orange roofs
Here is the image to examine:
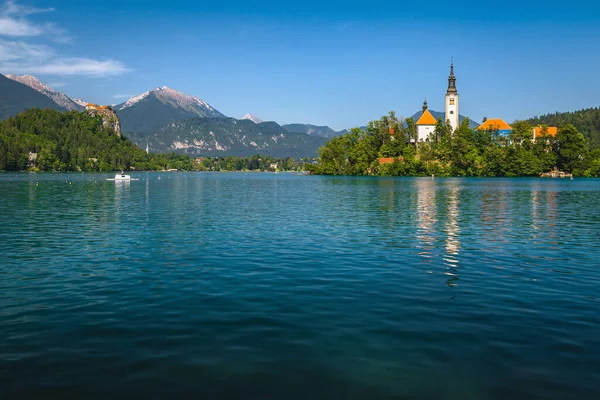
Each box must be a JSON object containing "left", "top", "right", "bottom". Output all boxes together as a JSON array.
[{"left": 307, "top": 64, "right": 600, "bottom": 177}]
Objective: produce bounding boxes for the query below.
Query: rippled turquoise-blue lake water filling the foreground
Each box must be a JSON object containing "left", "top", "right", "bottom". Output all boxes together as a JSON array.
[{"left": 0, "top": 173, "right": 600, "bottom": 399}]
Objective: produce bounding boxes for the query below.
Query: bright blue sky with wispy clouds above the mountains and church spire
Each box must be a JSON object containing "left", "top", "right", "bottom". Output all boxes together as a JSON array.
[{"left": 0, "top": 0, "right": 600, "bottom": 129}]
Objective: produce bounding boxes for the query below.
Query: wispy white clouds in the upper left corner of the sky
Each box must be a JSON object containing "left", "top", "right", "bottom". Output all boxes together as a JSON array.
[{"left": 0, "top": 0, "right": 130, "bottom": 77}]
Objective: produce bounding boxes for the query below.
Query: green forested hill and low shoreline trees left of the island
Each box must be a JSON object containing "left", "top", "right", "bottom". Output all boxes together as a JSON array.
[{"left": 0, "top": 109, "right": 301, "bottom": 171}]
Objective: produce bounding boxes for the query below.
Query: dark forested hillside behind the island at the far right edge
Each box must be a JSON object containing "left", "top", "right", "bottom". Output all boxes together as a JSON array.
[{"left": 527, "top": 107, "right": 600, "bottom": 150}]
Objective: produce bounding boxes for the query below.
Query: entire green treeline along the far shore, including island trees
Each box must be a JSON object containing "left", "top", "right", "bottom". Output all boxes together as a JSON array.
[{"left": 0, "top": 109, "right": 600, "bottom": 177}]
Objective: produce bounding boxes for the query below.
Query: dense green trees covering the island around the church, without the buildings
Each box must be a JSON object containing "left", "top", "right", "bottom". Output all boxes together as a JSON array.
[{"left": 307, "top": 112, "right": 600, "bottom": 176}]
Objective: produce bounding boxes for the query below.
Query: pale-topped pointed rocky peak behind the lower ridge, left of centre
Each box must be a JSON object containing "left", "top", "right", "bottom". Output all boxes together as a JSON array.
[{"left": 115, "top": 86, "right": 225, "bottom": 133}]
